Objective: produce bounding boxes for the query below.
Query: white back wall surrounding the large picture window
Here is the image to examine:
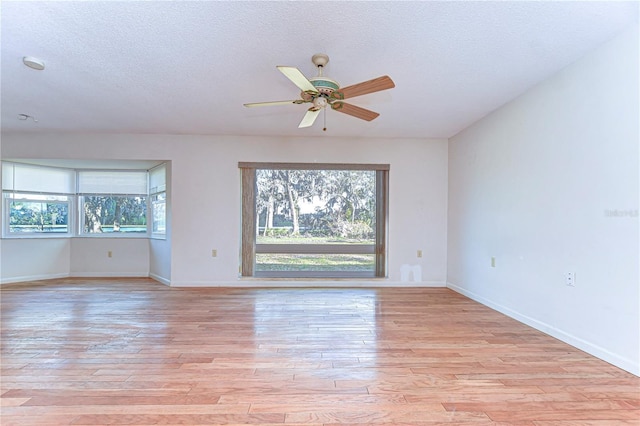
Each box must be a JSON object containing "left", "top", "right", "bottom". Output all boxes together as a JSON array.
[{"left": 2, "top": 134, "right": 447, "bottom": 286}]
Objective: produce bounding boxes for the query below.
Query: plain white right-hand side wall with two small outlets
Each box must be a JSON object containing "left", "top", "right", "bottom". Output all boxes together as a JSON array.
[{"left": 447, "top": 28, "right": 640, "bottom": 375}]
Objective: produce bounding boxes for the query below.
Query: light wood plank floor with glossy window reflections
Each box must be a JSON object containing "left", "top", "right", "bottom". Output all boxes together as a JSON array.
[{"left": 0, "top": 279, "right": 640, "bottom": 426}]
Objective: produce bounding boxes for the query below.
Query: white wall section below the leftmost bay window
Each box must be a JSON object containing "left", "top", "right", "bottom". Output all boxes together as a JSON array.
[{"left": 0, "top": 238, "right": 71, "bottom": 283}]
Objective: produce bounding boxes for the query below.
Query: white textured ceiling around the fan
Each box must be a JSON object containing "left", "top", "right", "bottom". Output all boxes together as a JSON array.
[{"left": 0, "top": 0, "right": 638, "bottom": 138}]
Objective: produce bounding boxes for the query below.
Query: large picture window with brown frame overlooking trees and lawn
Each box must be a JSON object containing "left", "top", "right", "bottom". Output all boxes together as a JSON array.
[{"left": 239, "top": 163, "right": 389, "bottom": 277}]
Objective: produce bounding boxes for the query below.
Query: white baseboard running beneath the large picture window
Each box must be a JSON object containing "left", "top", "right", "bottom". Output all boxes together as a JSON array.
[{"left": 169, "top": 277, "right": 446, "bottom": 288}]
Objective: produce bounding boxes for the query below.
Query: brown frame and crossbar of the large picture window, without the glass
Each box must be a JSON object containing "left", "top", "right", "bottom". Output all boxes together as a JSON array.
[{"left": 238, "top": 162, "right": 390, "bottom": 279}]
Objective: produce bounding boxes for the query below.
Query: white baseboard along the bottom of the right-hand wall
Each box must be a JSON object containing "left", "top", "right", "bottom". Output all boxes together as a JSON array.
[{"left": 447, "top": 282, "right": 640, "bottom": 376}]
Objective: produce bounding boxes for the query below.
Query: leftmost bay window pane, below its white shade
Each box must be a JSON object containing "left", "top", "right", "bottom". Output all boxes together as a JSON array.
[{"left": 4, "top": 193, "right": 70, "bottom": 236}]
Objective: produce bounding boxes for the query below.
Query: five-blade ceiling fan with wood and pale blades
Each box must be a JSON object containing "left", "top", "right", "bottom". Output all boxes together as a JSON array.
[{"left": 244, "top": 53, "right": 396, "bottom": 130}]
